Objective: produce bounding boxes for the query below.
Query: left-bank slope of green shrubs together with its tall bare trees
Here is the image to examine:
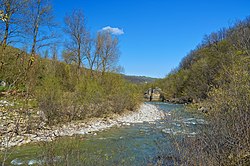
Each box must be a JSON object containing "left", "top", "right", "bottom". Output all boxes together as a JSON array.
[{"left": 0, "top": 0, "right": 141, "bottom": 124}]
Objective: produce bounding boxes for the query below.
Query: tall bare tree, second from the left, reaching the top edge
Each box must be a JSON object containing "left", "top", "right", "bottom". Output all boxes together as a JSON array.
[{"left": 23, "top": 0, "right": 56, "bottom": 56}]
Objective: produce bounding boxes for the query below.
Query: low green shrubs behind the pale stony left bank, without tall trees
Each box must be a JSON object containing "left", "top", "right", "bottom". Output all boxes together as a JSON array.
[{"left": 0, "top": 47, "right": 141, "bottom": 124}]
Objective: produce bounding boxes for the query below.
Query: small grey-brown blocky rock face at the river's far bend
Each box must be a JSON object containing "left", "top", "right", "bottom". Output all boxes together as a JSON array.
[{"left": 144, "top": 87, "right": 164, "bottom": 101}]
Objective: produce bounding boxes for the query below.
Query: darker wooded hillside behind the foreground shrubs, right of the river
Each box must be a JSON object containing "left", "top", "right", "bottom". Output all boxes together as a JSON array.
[{"left": 157, "top": 16, "right": 250, "bottom": 102}]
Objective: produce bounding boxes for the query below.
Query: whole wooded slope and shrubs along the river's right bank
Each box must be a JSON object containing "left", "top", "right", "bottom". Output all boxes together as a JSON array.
[{"left": 158, "top": 17, "right": 250, "bottom": 165}]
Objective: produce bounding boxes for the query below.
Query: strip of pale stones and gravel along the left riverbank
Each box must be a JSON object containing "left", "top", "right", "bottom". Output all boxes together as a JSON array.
[{"left": 0, "top": 103, "right": 166, "bottom": 149}]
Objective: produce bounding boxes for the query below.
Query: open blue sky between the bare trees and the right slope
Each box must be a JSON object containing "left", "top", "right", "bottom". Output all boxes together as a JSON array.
[{"left": 53, "top": 0, "right": 250, "bottom": 78}]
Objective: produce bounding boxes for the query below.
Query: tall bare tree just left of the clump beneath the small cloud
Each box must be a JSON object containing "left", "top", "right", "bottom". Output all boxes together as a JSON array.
[{"left": 64, "top": 10, "right": 89, "bottom": 75}]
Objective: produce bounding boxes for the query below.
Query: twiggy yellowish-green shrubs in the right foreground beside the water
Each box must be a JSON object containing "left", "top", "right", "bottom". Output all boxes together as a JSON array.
[{"left": 182, "top": 57, "right": 250, "bottom": 165}]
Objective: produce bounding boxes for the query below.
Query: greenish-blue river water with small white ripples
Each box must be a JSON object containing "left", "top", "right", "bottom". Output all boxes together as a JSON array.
[{"left": 7, "top": 103, "right": 206, "bottom": 166}]
